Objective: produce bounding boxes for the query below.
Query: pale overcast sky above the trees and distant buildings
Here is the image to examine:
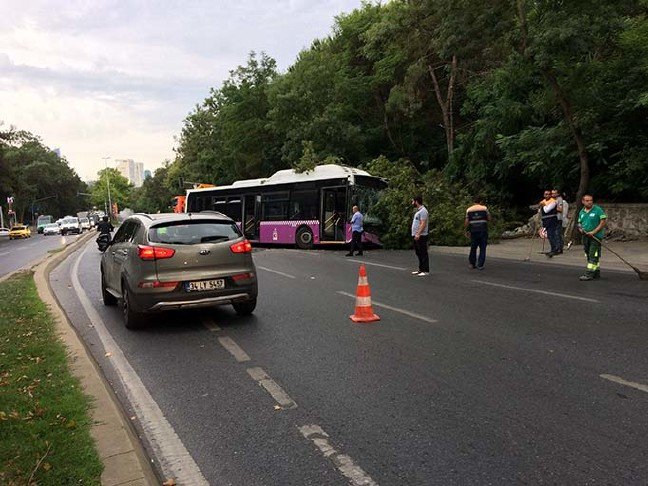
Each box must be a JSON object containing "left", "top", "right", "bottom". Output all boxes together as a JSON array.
[{"left": 0, "top": 0, "right": 361, "bottom": 180}]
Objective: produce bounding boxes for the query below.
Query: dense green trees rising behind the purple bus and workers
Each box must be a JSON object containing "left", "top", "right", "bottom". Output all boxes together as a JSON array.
[{"left": 167, "top": 0, "right": 648, "bottom": 245}]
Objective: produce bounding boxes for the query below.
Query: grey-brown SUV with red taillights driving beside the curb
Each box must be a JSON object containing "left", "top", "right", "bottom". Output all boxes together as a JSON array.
[{"left": 101, "top": 212, "right": 258, "bottom": 329}]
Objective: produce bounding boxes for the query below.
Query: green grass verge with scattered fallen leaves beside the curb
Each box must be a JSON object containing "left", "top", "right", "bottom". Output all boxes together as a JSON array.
[{"left": 0, "top": 273, "right": 103, "bottom": 486}]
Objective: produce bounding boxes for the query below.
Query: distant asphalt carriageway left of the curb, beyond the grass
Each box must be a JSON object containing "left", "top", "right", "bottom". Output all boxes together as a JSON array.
[{"left": 0, "top": 232, "right": 84, "bottom": 277}]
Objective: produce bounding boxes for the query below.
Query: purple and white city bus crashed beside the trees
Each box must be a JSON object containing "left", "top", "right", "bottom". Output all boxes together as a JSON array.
[{"left": 186, "top": 164, "right": 387, "bottom": 249}]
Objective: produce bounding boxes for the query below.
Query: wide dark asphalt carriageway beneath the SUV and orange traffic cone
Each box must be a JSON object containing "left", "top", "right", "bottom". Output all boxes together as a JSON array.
[{"left": 51, "top": 244, "right": 648, "bottom": 485}]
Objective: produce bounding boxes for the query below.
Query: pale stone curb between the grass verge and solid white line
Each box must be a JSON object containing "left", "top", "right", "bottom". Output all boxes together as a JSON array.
[{"left": 31, "top": 233, "right": 161, "bottom": 486}]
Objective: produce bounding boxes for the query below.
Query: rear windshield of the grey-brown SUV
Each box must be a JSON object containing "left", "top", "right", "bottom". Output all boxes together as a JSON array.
[{"left": 148, "top": 220, "right": 241, "bottom": 245}]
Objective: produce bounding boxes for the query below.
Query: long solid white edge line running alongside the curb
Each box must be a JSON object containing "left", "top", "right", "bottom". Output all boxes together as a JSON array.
[{"left": 71, "top": 245, "right": 209, "bottom": 486}]
